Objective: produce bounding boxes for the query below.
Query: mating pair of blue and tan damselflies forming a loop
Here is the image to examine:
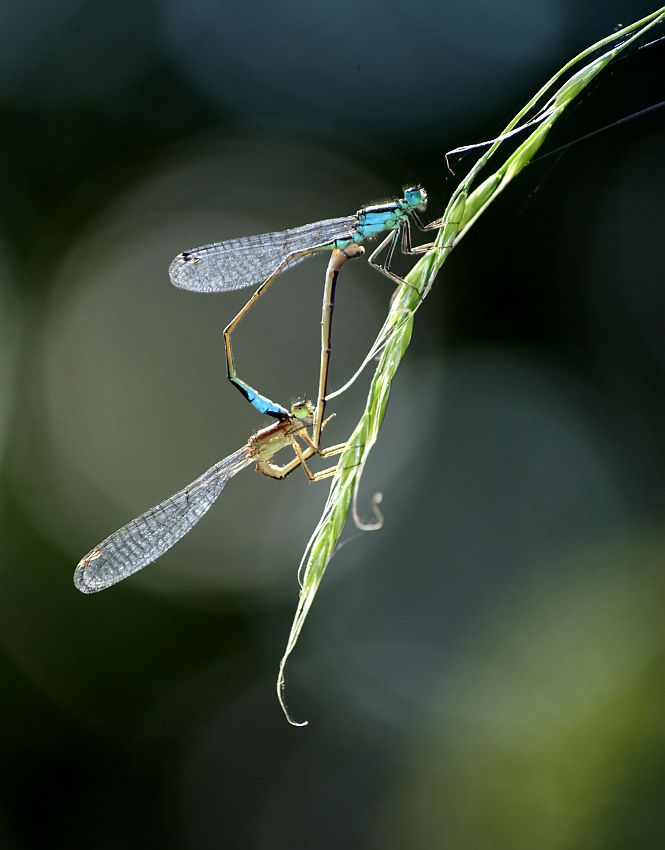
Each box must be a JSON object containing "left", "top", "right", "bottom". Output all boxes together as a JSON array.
[{"left": 74, "top": 186, "right": 440, "bottom": 593}]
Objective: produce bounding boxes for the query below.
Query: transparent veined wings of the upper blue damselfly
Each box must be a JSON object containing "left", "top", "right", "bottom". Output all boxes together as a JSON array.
[{"left": 169, "top": 215, "right": 358, "bottom": 292}]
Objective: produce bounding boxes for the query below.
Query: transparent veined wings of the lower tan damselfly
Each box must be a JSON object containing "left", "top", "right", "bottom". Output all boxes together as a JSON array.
[{"left": 74, "top": 446, "right": 252, "bottom": 593}]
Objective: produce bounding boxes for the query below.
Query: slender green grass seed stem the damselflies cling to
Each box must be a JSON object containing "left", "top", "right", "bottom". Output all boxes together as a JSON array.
[{"left": 277, "top": 7, "right": 665, "bottom": 726}]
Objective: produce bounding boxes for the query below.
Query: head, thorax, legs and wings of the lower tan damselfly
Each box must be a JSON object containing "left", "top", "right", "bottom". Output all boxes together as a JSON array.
[{"left": 74, "top": 401, "right": 344, "bottom": 593}]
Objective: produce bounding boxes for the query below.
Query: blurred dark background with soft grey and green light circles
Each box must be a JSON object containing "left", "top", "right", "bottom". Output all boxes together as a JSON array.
[{"left": 0, "top": 0, "right": 665, "bottom": 850}]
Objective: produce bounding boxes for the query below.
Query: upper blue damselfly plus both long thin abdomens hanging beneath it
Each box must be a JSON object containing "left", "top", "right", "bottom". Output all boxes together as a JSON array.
[{"left": 169, "top": 186, "right": 439, "bottom": 447}]
